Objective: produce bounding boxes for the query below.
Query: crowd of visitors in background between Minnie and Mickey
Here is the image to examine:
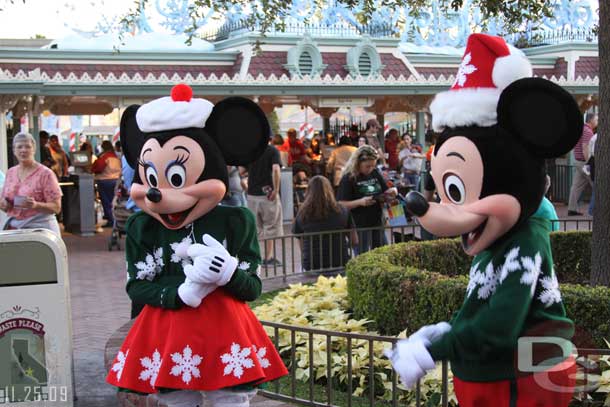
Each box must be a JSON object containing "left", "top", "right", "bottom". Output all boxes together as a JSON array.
[{"left": 214, "top": 119, "right": 426, "bottom": 270}]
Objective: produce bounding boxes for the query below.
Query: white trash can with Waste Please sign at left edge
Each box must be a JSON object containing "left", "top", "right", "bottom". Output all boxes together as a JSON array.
[{"left": 0, "top": 229, "right": 74, "bottom": 407}]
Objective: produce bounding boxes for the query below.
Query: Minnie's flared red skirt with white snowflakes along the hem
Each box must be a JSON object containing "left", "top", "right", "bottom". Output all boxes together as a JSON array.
[{"left": 106, "top": 289, "right": 288, "bottom": 393}]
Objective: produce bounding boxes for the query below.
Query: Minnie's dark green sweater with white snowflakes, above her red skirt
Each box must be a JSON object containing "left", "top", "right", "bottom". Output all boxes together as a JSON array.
[{"left": 125, "top": 206, "right": 262, "bottom": 309}]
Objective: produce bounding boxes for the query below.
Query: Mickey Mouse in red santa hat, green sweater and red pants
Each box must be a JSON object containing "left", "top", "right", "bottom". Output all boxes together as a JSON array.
[{"left": 388, "top": 34, "right": 583, "bottom": 407}]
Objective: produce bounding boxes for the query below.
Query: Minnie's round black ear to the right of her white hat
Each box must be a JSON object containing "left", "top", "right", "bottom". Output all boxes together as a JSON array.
[{"left": 205, "top": 97, "right": 271, "bottom": 165}]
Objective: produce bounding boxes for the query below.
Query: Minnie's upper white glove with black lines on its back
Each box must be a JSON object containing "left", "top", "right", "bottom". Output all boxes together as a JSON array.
[{"left": 184, "top": 234, "right": 237, "bottom": 286}]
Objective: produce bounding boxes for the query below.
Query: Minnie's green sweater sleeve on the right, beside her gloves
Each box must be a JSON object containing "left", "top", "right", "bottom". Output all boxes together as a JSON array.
[{"left": 224, "top": 208, "right": 262, "bottom": 301}]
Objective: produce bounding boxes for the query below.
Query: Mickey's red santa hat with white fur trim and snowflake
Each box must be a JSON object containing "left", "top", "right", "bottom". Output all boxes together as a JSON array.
[{"left": 430, "top": 34, "right": 532, "bottom": 132}]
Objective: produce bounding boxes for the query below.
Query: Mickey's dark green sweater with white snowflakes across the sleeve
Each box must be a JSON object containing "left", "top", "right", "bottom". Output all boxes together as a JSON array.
[{"left": 428, "top": 217, "right": 574, "bottom": 382}]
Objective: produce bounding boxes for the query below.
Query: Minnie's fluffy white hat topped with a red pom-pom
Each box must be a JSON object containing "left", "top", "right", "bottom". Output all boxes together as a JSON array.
[{"left": 136, "top": 83, "right": 214, "bottom": 133}]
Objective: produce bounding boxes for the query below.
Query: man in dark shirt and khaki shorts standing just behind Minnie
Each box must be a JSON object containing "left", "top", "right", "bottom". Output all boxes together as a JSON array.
[{"left": 242, "top": 145, "right": 282, "bottom": 266}]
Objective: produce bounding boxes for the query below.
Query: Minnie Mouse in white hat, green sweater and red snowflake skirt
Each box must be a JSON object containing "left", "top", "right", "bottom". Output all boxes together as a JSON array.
[{"left": 107, "top": 84, "right": 287, "bottom": 407}]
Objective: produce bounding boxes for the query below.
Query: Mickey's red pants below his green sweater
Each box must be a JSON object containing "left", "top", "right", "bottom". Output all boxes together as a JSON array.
[{"left": 453, "top": 358, "right": 576, "bottom": 407}]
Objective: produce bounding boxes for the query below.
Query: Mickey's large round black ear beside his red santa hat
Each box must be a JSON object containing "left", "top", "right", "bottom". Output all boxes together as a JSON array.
[{"left": 498, "top": 78, "right": 583, "bottom": 158}]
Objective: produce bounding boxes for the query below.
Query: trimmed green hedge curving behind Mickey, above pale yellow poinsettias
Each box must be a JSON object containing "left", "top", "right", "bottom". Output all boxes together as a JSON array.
[{"left": 346, "top": 232, "right": 610, "bottom": 348}]
